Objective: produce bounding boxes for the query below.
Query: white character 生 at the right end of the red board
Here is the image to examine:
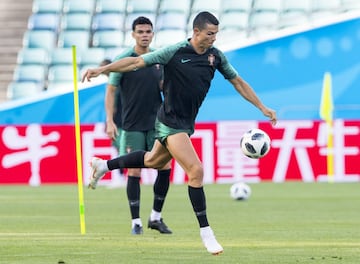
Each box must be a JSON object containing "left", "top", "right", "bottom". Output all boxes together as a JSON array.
[{"left": 317, "top": 120, "right": 360, "bottom": 182}]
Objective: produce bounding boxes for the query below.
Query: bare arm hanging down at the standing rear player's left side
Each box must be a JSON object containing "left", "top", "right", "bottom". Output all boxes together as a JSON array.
[{"left": 105, "top": 84, "right": 121, "bottom": 140}]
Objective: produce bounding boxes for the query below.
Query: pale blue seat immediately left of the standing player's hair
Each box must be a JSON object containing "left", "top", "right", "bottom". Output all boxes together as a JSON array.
[{"left": 92, "top": 13, "right": 124, "bottom": 31}]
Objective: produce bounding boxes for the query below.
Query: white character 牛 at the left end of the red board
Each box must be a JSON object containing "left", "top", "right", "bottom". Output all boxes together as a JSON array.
[{"left": 2, "top": 124, "right": 60, "bottom": 186}]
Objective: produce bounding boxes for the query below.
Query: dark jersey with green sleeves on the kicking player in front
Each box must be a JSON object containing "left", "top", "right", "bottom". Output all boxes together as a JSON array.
[{"left": 141, "top": 40, "right": 237, "bottom": 129}]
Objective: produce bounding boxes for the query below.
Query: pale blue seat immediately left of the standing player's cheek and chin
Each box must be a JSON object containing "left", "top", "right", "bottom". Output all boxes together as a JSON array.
[{"left": 92, "top": 30, "right": 124, "bottom": 48}]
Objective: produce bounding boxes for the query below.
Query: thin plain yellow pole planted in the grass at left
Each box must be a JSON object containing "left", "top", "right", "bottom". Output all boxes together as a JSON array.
[{"left": 72, "top": 46, "right": 86, "bottom": 235}]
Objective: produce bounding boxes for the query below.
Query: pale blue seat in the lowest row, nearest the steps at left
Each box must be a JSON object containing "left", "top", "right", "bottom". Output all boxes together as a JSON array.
[{"left": 6, "top": 82, "right": 43, "bottom": 100}]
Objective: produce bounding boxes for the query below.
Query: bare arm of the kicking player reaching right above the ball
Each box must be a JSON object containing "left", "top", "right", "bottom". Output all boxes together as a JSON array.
[{"left": 229, "top": 75, "right": 277, "bottom": 125}]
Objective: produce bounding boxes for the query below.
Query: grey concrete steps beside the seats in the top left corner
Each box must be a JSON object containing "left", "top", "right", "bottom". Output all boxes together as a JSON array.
[{"left": 0, "top": 0, "right": 32, "bottom": 103}]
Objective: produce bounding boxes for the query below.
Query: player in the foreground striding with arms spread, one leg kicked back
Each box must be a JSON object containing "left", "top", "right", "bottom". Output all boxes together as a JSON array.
[{"left": 83, "top": 12, "right": 277, "bottom": 255}]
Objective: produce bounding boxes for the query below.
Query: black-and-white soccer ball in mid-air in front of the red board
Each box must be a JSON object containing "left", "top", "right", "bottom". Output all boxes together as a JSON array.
[{"left": 240, "top": 128, "right": 270, "bottom": 159}]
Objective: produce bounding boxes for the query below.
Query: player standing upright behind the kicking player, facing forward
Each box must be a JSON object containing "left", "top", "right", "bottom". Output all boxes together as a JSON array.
[{"left": 99, "top": 16, "right": 172, "bottom": 235}]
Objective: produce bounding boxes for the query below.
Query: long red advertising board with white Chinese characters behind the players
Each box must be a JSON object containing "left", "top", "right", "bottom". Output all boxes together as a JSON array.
[{"left": 0, "top": 120, "right": 360, "bottom": 186}]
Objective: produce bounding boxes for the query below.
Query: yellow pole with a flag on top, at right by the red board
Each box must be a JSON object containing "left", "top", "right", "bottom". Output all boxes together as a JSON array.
[{"left": 320, "top": 72, "right": 334, "bottom": 182}]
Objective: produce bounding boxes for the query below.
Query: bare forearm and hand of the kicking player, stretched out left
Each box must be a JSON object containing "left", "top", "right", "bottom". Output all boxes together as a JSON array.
[{"left": 82, "top": 56, "right": 146, "bottom": 82}]
